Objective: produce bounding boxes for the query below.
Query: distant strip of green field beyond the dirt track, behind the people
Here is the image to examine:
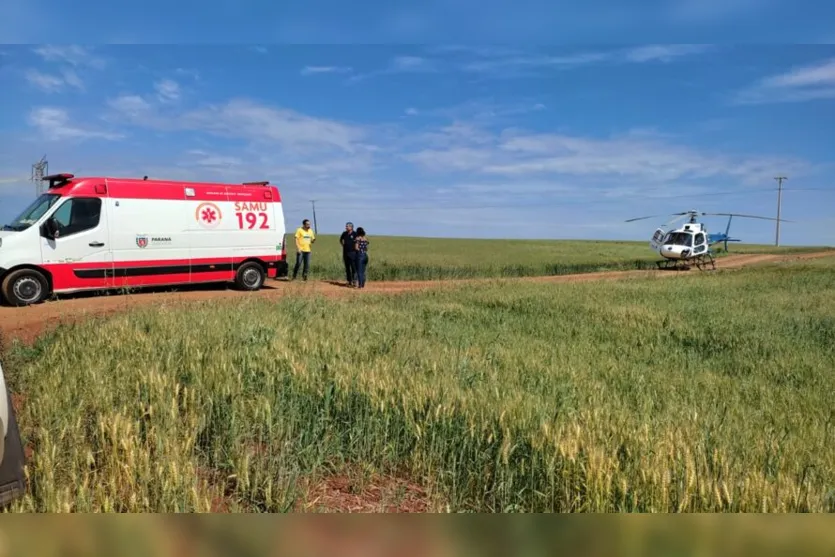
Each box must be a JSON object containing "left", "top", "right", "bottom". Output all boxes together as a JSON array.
[{"left": 287, "top": 235, "right": 820, "bottom": 281}]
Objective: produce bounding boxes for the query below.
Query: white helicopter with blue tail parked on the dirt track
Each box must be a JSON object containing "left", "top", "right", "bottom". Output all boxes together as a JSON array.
[{"left": 625, "top": 210, "right": 790, "bottom": 270}]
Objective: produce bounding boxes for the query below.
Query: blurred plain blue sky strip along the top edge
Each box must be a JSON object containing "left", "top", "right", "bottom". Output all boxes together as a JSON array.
[{"left": 0, "top": 0, "right": 835, "bottom": 45}]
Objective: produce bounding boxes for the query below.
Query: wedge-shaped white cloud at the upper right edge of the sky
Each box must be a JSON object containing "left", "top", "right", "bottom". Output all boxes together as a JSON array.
[{"left": 735, "top": 58, "right": 835, "bottom": 104}]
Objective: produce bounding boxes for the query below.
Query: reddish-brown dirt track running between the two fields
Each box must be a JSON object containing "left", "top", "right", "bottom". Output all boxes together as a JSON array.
[{"left": 0, "top": 251, "right": 835, "bottom": 347}]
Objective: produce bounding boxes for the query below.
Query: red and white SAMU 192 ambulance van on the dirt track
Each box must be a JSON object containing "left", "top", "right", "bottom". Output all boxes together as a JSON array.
[{"left": 0, "top": 174, "right": 287, "bottom": 306}]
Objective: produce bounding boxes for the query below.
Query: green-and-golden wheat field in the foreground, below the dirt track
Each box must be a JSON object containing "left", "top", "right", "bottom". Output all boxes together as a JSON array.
[{"left": 4, "top": 254, "right": 835, "bottom": 512}]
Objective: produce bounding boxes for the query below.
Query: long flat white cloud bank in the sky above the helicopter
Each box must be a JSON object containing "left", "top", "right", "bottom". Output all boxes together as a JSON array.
[{"left": 403, "top": 122, "right": 808, "bottom": 185}]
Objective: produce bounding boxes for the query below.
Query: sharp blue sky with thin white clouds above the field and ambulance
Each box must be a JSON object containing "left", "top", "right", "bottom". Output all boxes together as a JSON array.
[{"left": 0, "top": 43, "right": 835, "bottom": 245}]
